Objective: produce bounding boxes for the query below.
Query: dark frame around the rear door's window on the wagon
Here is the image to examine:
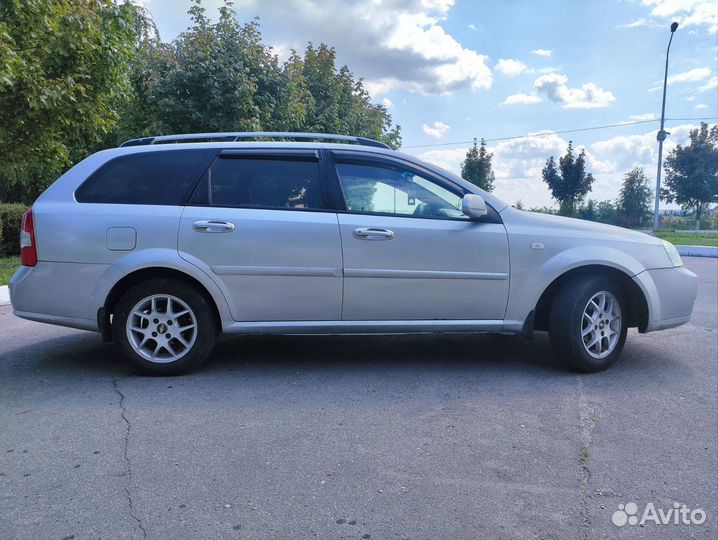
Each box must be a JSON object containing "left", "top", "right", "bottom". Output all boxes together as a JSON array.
[{"left": 185, "top": 152, "right": 336, "bottom": 213}]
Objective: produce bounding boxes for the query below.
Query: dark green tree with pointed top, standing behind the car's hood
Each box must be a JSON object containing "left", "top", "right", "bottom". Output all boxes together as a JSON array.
[{"left": 541, "top": 141, "right": 594, "bottom": 216}]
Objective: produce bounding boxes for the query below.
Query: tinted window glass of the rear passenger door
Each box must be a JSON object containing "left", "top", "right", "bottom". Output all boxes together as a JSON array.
[{"left": 208, "top": 158, "right": 322, "bottom": 209}]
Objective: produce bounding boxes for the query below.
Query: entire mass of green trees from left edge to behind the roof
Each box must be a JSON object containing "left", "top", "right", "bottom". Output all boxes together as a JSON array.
[{"left": 0, "top": 0, "right": 401, "bottom": 202}]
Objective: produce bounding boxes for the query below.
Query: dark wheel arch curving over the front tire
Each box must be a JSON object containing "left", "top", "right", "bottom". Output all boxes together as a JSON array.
[{"left": 533, "top": 264, "right": 649, "bottom": 332}]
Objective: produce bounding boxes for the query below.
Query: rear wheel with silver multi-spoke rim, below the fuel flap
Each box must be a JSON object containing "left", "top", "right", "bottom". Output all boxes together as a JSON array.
[{"left": 112, "top": 279, "right": 217, "bottom": 375}]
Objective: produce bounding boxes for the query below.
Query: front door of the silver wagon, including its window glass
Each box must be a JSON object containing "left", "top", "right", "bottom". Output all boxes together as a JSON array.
[{"left": 335, "top": 154, "right": 509, "bottom": 320}]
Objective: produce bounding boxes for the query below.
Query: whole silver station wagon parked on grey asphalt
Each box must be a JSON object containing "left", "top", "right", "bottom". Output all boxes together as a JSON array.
[{"left": 10, "top": 133, "right": 696, "bottom": 374}]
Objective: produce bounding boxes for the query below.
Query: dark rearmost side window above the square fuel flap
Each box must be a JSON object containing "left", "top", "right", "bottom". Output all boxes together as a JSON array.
[{"left": 75, "top": 149, "right": 216, "bottom": 206}]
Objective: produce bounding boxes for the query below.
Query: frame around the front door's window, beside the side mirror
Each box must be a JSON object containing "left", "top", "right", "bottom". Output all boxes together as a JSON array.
[{"left": 327, "top": 150, "right": 503, "bottom": 223}]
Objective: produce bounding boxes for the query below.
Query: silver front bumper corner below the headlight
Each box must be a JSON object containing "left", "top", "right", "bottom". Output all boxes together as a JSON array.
[{"left": 633, "top": 266, "right": 698, "bottom": 332}]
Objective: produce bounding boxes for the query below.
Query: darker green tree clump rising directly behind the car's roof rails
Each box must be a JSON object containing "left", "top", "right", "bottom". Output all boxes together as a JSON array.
[{"left": 117, "top": 0, "right": 401, "bottom": 148}]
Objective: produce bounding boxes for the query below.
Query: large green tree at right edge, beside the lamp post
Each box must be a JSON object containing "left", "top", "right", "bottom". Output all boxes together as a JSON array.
[{"left": 661, "top": 122, "right": 718, "bottom": 229}]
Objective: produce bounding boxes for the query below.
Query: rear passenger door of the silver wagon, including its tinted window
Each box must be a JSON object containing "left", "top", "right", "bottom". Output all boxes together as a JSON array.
[{"left": 179, "top": 150, "right": 342, "bottom": 321}]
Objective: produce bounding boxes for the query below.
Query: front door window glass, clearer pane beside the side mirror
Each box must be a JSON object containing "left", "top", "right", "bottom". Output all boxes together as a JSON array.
[{"left": 336, "top": 163, "right": 468, "bottom": 219}]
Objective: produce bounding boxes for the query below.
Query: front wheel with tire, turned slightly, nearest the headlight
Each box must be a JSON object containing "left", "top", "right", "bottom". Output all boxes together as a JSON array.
[{"left": 549, "top": 276, "right": 628, "bottom": 373}]
